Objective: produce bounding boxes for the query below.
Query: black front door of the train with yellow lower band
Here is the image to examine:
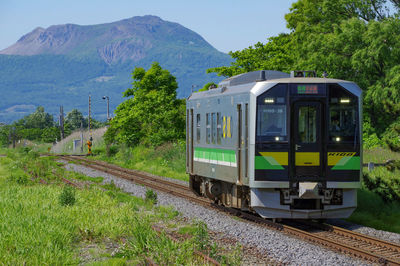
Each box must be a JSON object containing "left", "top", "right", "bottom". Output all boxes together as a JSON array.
[{"left": 292, "top": 101, "right": 323, "bottom": 181}]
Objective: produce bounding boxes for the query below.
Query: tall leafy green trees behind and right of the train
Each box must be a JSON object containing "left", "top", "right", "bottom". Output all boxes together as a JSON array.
[{"left": 208, "top": 0, "right": 400, "bottom": 151}]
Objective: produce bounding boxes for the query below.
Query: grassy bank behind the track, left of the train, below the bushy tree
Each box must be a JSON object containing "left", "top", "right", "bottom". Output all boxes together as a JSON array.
[{"left": 93, "top": 142, "right": 189, "bottom": 181}]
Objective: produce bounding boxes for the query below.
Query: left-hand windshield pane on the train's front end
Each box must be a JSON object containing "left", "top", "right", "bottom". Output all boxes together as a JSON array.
[{"left": 257, "top": 84, "right": 287, "bottom": 142}]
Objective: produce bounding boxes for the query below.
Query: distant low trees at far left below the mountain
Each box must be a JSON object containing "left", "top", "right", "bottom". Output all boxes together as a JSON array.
[{"left": 0, "top": 106, "right": 105, "bottom": 146}]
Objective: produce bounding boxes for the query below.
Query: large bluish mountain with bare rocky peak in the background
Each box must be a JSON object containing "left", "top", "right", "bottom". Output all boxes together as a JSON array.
[{"left": 0, "top": 16, "right": 231, "bottom": 122}]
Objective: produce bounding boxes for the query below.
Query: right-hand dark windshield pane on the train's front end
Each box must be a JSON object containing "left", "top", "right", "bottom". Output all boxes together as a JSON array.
[{"left": 329, "top": 84, "right": 358, "bottom": 142}]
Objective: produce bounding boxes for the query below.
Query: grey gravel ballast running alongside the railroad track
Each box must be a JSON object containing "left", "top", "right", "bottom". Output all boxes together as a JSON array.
[{"left": 64, "top": 161, "right": 400, "bottom": 265}]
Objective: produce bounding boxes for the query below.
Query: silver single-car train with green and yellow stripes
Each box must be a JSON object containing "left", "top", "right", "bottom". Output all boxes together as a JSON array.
[{"left": 186, "top": 70, "right": 362, "bottom": 219}]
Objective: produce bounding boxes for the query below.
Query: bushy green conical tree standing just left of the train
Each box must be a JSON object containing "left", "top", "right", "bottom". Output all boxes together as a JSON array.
[{"left": 105, "top": 62, "right": 185, "bottom": 146}]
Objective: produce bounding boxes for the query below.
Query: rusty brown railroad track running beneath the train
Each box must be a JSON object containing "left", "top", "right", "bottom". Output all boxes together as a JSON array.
[{"left": 60, "top": 156, "right": 400, "bottom": 265}]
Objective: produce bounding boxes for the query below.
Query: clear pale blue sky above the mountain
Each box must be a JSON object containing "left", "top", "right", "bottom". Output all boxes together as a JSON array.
[{"left": 0, "top": 0, "right": 295, "bottom": 53}]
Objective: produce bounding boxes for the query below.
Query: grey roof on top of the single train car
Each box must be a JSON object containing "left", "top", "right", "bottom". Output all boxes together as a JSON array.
[{"left": 188, "top": 70, "right": 361, "bottom": 100}]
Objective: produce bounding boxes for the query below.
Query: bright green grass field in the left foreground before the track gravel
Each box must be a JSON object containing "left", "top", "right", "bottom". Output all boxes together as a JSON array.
[{"left": 0, "top": 149, "right": 240, "bottom": 265}]
